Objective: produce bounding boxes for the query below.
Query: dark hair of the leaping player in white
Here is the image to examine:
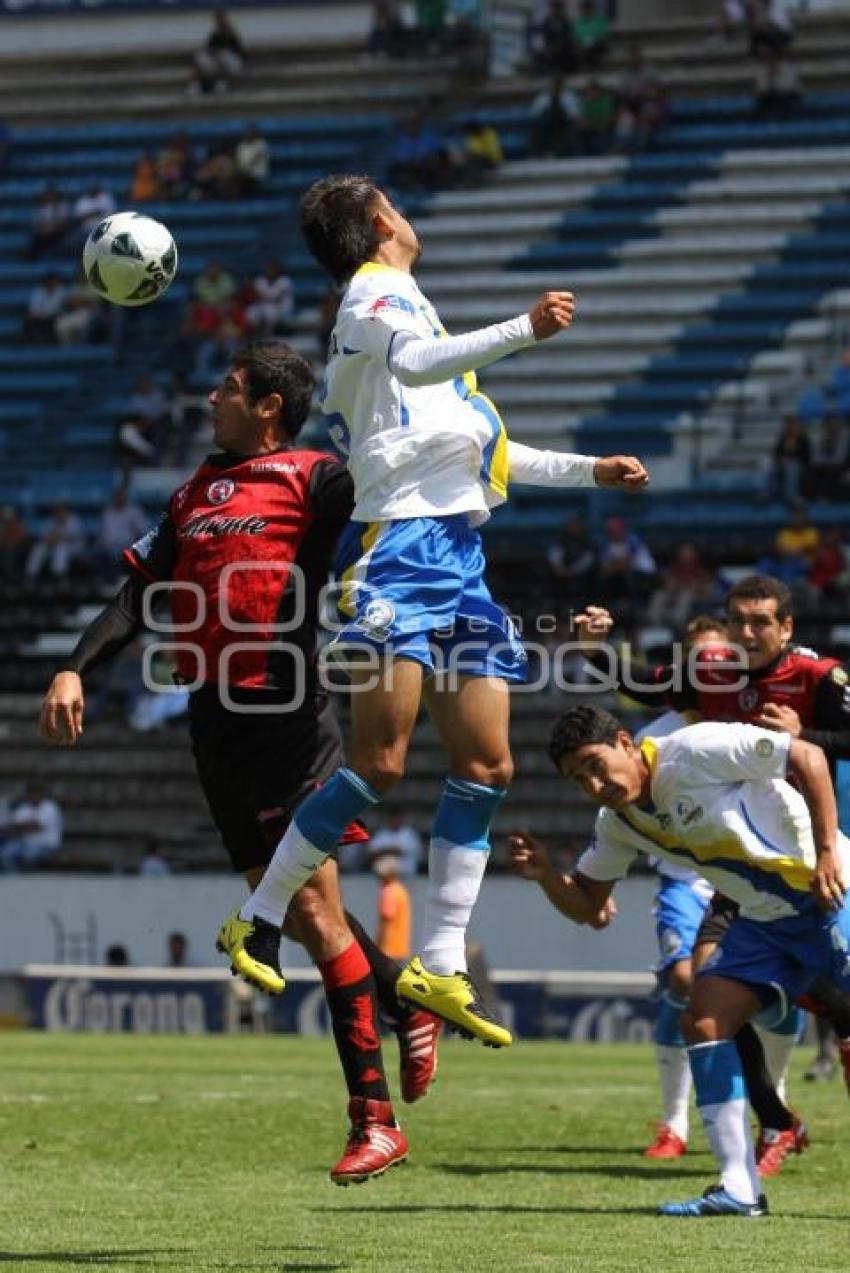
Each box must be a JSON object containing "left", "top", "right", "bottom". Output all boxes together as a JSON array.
[{"left": 298, "top": 173, "right": 379, "bottom": 283}]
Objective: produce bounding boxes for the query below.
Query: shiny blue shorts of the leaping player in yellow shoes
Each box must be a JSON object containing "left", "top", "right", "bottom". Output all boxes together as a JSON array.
[{"left": 331, "top": 513, "right": 528, "bottom": 681}]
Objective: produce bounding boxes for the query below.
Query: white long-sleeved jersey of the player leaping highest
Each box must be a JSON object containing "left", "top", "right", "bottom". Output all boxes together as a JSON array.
[{"left": 319, "top": 262, "right": 594, "bottom": 524}]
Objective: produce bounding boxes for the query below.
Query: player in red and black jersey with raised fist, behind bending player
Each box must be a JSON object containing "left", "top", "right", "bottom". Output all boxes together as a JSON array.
[{"left": 576, "top": 574, "right": 850, "bottom": 1110}]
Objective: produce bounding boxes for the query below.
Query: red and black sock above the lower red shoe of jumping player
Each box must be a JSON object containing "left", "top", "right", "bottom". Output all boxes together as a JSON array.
[{"left": 319, "top": 941, "right": 389, "bottom": 1101}]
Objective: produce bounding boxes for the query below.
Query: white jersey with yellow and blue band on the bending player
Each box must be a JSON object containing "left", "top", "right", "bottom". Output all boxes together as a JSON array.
[{"left": 576, "top": 722, "right": 850, "bottom": 922}]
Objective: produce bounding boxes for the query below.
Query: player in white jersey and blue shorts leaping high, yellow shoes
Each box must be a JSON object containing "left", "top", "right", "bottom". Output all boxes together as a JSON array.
[{"left": 219, "top": 176, "right": 648, "bottom": 1046}]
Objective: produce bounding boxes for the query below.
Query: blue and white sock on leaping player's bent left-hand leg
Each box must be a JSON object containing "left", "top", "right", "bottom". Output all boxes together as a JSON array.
[{"left": 239, "top": 769, "right": 380, "bottom": 928}]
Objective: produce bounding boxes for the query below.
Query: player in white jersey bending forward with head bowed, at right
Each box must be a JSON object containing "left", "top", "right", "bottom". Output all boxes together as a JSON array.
[{"left": 512, "top": 705, "right": 850, "bottom": 1217}]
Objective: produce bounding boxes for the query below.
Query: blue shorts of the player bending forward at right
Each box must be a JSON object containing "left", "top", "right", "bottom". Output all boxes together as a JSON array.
[{"left": 699, "top": 901, "right": 850, "bottom": 1004}]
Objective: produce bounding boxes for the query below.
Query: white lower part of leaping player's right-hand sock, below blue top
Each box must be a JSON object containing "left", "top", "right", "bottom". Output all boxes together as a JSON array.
[{"left": 420, "top": 841, "right": 490, "bottom": 975}]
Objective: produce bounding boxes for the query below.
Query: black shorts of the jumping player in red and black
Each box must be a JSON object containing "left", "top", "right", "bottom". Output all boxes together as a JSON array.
[{"left": 190, "top": 686, "right": 344, "bottom": 873}]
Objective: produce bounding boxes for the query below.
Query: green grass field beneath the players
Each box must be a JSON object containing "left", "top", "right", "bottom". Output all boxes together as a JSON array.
[{"left": 0, "top": 1034, "right": 850, "bottom": 1273}]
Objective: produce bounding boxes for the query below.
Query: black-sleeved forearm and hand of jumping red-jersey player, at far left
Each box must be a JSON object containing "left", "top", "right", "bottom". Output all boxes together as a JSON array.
[{"left": 38, "top": 575, "right": 145, "bottom": 746}]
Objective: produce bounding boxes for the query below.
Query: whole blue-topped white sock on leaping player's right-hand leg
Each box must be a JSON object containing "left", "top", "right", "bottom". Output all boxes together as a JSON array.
[{"left": 420, "top": 778, "right": 506, "bottom": 974}]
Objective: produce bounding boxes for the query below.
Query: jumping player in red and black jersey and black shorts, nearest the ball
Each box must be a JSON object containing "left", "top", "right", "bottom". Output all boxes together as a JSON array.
[{"left": 41, "top": 341, "right": 439, "bottom": 1184}]
